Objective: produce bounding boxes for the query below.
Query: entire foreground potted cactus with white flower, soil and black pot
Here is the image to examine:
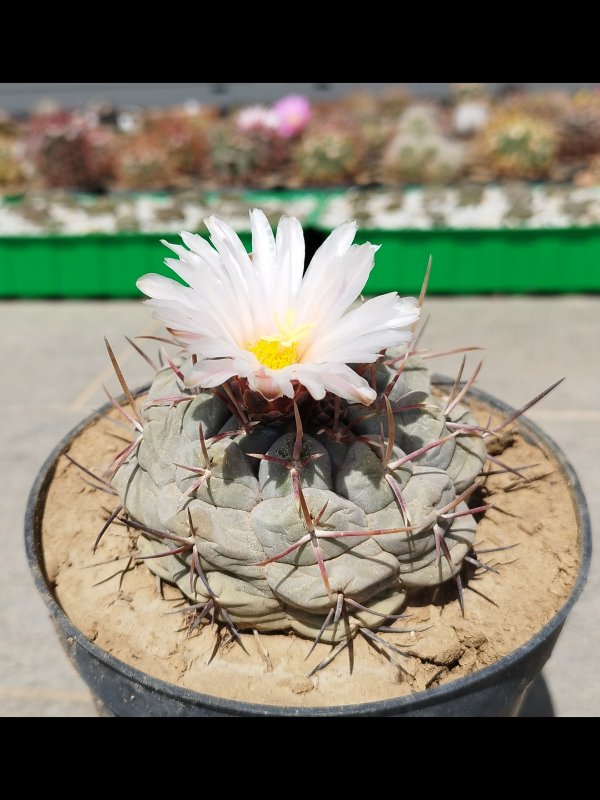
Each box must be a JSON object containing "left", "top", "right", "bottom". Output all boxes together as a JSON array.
[{"left": 26, "top": 210, "right": 590, "bottom": 715}]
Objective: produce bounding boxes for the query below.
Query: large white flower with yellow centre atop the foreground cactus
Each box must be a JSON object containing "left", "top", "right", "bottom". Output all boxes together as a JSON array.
[{"left": 137, "top": 209, "right": 419, "bottom": 405}]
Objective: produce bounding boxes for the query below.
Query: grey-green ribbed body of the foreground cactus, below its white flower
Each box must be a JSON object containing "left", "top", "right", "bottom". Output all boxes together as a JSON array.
[{"left": 113, "top": 354, "right": 486, "bottom": 642}]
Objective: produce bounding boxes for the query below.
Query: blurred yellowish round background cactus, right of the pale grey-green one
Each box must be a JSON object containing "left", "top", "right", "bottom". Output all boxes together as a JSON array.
[{"left": 476, "top": 111, "right": 559, "bottom": 180}]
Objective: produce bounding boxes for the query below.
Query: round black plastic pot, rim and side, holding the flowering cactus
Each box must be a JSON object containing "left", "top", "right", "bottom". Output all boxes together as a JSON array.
[{"left": 25, "top": 389, "right": 592, "bottom": 717}]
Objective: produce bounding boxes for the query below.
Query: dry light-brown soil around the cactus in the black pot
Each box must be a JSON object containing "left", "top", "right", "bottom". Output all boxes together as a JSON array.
[{"left": 42, "top": 394, "right": 578, "bottom": 707}]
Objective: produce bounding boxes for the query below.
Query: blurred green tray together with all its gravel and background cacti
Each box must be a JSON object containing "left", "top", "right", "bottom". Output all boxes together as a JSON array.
[{"left": 5, "top": 84, "right": 600, "bottom": 297}]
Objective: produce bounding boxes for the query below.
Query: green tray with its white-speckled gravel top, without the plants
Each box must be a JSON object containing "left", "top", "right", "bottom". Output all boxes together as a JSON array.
[{"left": 0, "top": 187, "right": 600, "bottom": 298}]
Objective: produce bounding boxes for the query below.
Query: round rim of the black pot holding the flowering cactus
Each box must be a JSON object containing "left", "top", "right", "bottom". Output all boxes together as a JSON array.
[{"left": 25, "top": 374, "right": 592, "bottom": 716}]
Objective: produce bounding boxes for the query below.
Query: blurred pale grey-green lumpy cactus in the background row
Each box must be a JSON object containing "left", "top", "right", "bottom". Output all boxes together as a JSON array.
[{"left": 380, "top": 105, "right": 465, "bottom": 183}]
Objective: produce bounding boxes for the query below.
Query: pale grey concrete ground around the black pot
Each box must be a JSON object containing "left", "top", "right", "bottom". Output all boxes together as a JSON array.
[{"left": 0, "top": 296, "right": 600, "bottom": 716}]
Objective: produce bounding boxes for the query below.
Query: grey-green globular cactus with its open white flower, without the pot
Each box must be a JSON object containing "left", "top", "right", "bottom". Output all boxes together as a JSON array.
[{"left": 96, "top": 211, "right": 504, "bottom": 664}]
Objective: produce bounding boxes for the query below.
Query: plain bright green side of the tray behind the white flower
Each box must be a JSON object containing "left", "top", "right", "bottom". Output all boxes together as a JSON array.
[{"left": 0, "top": 211, "right": 600, "bottom": 298}]
